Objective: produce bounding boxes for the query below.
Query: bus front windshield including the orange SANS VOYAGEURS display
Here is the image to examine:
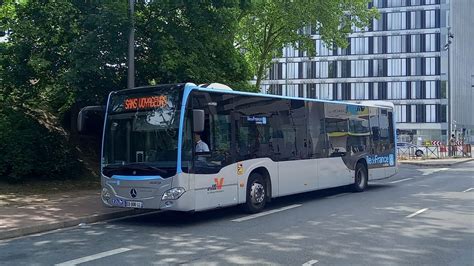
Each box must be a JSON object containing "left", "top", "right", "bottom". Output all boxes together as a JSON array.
[{"left": 102, "top": 86, "right": 181, "bottom": 177}]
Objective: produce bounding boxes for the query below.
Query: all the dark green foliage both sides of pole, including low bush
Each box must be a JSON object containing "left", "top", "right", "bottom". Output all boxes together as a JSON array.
[{"left": 0, "top": 0, "right": 254, "bottom": 179}]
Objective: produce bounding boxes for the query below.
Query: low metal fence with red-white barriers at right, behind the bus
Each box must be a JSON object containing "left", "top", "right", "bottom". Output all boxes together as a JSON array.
[{"left": 397, "top": 144, "right": 472, "bottom": 159}]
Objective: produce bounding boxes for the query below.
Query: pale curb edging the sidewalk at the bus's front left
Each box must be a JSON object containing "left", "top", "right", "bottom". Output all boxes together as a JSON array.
[{"left": 0, "top": 209, "right": 149, "bottom": 240}]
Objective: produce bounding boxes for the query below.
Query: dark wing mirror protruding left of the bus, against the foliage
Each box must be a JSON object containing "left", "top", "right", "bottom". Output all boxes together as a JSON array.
[{"left": 77, "top": 105, "right": 105, "bottom": 135}]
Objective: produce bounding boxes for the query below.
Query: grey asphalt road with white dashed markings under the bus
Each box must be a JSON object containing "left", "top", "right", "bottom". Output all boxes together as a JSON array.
[{"left": 0, "top": 162, "right": 474, "bottom": 266}]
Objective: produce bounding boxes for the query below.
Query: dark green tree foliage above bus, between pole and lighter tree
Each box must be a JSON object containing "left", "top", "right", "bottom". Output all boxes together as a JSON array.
[{"left": 136, "top": 0, "right": 250, "bottom": 89}]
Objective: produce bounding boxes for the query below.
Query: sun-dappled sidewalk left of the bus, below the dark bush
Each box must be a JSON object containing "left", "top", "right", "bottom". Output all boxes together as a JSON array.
[{"left": 0, "top": 190, "right": 149, "bottom": 239}]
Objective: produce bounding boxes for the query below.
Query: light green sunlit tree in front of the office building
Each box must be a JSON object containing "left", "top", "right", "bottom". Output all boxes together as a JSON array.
[{"left": 236, "top": 0, "right": 378, "bottom": 89}]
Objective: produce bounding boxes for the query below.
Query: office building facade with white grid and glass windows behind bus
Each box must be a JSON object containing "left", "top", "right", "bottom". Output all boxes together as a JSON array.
[{"left": 261, "top": 0, "right": 472, "bottom": 144}]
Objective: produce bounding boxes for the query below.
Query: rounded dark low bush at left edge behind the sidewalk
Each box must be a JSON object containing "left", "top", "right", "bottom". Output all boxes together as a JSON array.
[{"left": 0, "top": 104, "right": 80, "bottom": 182}]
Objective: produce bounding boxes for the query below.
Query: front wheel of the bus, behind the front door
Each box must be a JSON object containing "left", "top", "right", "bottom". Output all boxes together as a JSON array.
[{"left": 244, "top": 173, "right": 268, "bottom": 213}]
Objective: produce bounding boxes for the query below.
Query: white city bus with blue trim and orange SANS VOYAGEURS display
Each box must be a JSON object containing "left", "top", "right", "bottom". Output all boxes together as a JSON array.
[{"left": 78, "top": 83, "right": 397, "bottom": 212}]
